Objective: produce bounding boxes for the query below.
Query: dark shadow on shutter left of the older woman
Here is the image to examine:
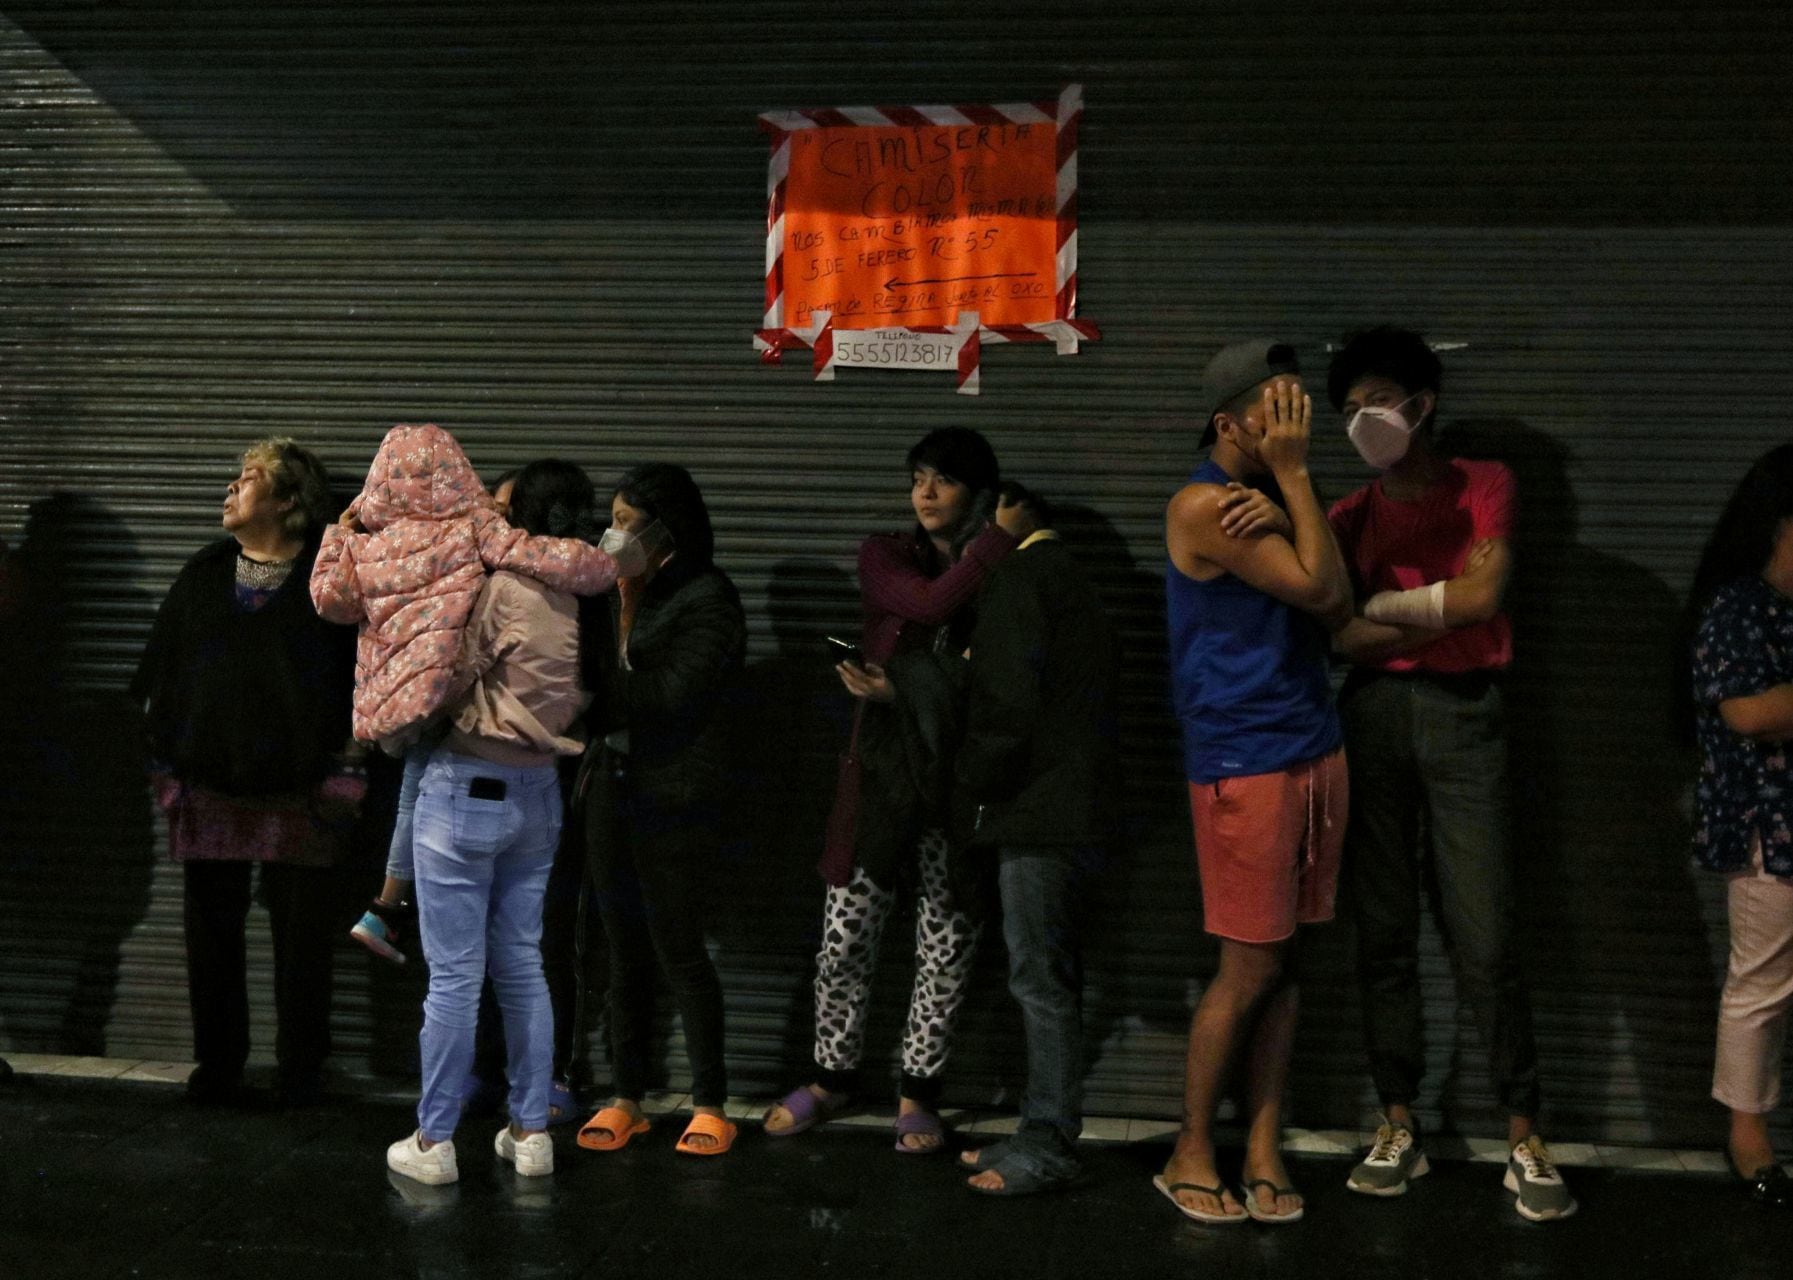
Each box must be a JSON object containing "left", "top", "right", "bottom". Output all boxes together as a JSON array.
[{"left": 0, "top": 493, "right": 154, "bottom": 1056}]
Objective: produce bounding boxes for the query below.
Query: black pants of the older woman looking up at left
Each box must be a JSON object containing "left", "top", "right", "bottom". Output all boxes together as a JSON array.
[{"left": 183, "top": 862, "right": 341, "bottom": 1086}]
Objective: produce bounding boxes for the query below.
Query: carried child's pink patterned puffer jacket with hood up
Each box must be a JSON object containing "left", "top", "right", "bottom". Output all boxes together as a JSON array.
[{"left": 312, "top": 423, "right": 617, "bottom": 742}]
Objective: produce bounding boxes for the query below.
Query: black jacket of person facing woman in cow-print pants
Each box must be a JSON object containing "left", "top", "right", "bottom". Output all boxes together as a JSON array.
[{"left": 954, "top": 540, "right": 1119, "bottom": 846}]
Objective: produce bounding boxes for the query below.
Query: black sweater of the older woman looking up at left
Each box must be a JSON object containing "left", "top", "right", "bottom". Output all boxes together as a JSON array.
[{"left": 131, "top": 538, "right": 355, "bottom": 796}]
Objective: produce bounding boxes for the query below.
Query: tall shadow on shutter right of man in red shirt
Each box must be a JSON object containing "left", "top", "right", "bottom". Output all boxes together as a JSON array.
[{"left": 1434, "top": 419, "right": 1716, "bottom": 1144}]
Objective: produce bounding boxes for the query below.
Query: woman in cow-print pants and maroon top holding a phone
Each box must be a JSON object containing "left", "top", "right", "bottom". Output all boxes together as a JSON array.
[{"left": 766, "top": 427, "right": 1015, "bottom": 1153}]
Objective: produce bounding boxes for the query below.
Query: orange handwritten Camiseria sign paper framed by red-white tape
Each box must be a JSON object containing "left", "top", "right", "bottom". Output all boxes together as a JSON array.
[{"left": 778, "top": 122, "right": 1058, "bottom": 330}]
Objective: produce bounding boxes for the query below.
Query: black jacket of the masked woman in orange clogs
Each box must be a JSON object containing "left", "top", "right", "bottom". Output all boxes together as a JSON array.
[{"left": 586, "top": 561, "right": 748, "bottom": 810}]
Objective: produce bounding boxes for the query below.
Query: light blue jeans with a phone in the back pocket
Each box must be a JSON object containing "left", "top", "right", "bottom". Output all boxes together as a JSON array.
[{"left": 414, "top": 749, "right": 561, "bottom": 1142}]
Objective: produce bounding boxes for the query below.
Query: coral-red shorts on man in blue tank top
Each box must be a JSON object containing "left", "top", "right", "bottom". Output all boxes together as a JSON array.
[{"left": 1189, "top": 748, "right": 1350, "bottom": 943}]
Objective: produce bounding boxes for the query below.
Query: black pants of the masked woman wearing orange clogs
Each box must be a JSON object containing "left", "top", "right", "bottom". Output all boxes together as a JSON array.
[{"left": 586, "top": 758, "right": 728, "bottom": 1106}]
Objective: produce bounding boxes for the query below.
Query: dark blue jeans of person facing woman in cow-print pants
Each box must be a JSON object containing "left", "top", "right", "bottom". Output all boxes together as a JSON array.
[{"left": 997, "top": 846, "right": 1096, "bottom": 1176}]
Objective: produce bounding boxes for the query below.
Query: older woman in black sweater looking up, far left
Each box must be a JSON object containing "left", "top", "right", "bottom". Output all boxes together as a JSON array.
[{"left": 131, "top": 439, "right": 362, "bottom": 1103}]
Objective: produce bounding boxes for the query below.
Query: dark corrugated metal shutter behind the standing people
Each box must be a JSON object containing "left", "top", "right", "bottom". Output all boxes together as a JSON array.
[{"left": 0, "top": 0, "right": 1793, "bottom": 1140}]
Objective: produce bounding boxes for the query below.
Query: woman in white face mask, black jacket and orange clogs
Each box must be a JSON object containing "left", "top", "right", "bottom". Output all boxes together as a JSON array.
[{"left": 579, "top": 463, "right": 746, "bottom": 1156}]
